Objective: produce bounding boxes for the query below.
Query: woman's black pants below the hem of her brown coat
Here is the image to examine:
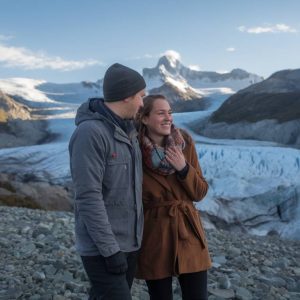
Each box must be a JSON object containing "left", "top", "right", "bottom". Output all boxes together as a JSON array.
[{"left": 146, "top": 271, "right": 207, "bottom": 300}]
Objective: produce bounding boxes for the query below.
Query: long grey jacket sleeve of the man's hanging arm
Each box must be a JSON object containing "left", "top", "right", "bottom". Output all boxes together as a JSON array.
[{"left": 69, "top": 122, "right": 120, "bottom": 257}]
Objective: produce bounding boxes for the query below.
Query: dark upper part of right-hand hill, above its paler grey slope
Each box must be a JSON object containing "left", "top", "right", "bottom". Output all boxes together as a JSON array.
[{"left": 210, "top": 69, "right": 300, "bottom": 124}]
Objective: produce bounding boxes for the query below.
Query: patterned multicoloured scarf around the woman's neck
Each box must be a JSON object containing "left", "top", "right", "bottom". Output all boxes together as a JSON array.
[{"left": 140, "top": 124, "right": 185, "bottom": 176}]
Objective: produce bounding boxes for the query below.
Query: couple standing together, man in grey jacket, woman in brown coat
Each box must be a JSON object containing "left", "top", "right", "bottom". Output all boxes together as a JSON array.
[{"left": 69, "top": 63, "right": 211, "bottom": 300}]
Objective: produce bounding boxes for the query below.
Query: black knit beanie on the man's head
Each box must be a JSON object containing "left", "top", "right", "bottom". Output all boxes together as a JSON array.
[{"left": 103, "top": 63, "right": 146, "bottom": 102}]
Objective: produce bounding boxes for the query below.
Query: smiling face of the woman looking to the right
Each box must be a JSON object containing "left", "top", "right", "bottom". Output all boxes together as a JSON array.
[{"left": 142, "top": 98, "right": 173, "bottom": 138}]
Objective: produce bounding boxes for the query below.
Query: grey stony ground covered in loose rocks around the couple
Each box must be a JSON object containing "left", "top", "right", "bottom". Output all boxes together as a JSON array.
[{"left": 0, "top": 206, "right": 300, "bottom": 300}]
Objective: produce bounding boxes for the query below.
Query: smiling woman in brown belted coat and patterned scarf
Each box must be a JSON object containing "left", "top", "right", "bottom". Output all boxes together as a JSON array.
[{"left": 137, "top": 95, "right": 211, "bottom": 300}]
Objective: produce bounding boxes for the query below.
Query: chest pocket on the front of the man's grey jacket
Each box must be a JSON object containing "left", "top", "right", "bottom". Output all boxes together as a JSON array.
[{"left": 103, "top": 161, "right": 130, "bottom": 189}]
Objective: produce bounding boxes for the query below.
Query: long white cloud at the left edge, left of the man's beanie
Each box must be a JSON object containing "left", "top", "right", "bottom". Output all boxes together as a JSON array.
[{"left": 0, "top": 44, "right": 102, "bottom": 71}]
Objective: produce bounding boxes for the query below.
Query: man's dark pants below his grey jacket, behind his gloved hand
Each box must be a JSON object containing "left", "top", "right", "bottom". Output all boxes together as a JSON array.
[{"left": 81, "top": 252, "right": 137, "bottom": 300}]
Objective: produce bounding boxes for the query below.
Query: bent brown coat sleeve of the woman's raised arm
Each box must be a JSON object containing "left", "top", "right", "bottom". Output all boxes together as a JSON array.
[{"left": 178, "top": 132, "right": 208, "bottom": 201}]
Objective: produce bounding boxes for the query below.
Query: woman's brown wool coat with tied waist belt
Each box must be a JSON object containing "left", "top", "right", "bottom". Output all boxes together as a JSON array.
[{"left": 136, "top": 132, "right": 211, "bottom": 280}]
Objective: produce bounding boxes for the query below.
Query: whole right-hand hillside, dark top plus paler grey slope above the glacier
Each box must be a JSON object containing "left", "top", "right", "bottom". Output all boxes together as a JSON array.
[{"left": 192, "top": 69, "right": 300, "bottom": 147}]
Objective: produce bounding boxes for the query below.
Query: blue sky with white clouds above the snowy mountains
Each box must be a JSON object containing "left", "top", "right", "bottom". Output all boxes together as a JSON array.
[{"left": 0, "top": 0, "right": 300, "bottom": 82}]
